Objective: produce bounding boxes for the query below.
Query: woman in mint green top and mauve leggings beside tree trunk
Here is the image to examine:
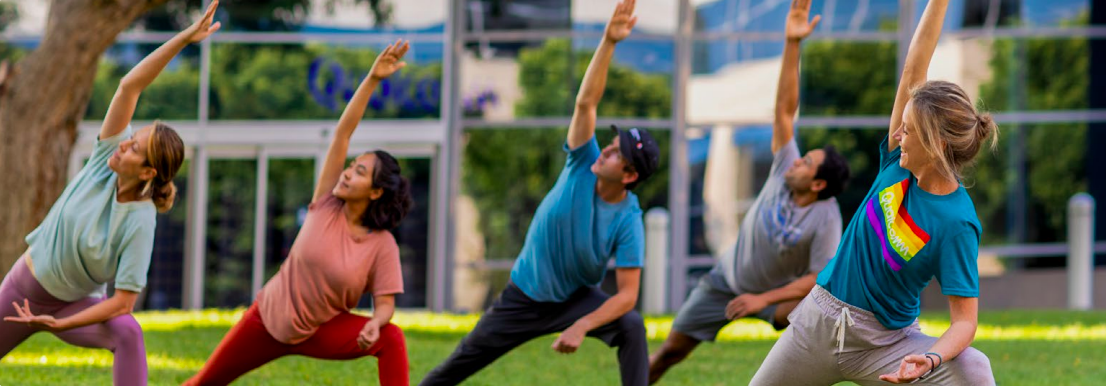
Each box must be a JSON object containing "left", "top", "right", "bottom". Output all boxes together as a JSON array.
[{"left": 0, "top": 1, "right": 219, "bottom": 385}]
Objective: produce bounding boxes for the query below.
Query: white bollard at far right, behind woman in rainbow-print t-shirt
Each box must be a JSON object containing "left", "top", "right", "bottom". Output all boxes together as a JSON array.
[{"left": 1067, "top": 192, "right": 1095, "bottom": 310}]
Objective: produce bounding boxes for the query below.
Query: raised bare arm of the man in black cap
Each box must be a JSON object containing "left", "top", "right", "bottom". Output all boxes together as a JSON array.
[{"left": 566, "top": 0, "right": 637, "bottom": 149}]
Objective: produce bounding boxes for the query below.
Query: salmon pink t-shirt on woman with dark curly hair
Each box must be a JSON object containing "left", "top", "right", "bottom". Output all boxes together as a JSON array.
[{"left": 258, "top": 192, "right": 404, "bottom": 344}]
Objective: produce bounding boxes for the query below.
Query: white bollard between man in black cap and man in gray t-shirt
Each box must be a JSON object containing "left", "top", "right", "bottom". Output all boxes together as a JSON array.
[{"left": 641, "top": 208, "right": 669, "bottom": 314}]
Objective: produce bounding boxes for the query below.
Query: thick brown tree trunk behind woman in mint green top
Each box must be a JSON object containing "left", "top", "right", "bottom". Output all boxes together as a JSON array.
[{"left": 0, "top": 0, "right": 165, "bottom": 274}]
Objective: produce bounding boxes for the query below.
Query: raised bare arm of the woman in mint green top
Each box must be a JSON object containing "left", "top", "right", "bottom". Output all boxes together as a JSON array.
[{"left": 100, "top": 0, "right": 220, "bottom": 138}]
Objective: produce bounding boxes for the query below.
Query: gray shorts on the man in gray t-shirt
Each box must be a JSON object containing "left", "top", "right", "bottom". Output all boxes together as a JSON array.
[{"left": 672, "top": 273, "right": 775, "bottom": 342}]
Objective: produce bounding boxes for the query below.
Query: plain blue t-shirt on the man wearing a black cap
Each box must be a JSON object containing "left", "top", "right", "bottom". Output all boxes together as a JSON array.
[{"left": 511, "top": 137, "right": 645, "bottom": 302}]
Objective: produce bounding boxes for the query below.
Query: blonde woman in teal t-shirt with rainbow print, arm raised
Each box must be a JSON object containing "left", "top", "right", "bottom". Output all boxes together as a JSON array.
[{"left": 751, "top": 0, "right": 998, "bottom": 385}]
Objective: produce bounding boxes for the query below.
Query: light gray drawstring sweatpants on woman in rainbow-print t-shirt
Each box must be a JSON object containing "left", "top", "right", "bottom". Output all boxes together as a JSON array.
[{"left": 750, "top": 285, "right": 994, "bottom": 386}]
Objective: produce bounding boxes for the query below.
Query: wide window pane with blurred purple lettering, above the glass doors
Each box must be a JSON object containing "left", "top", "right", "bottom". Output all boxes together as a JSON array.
[{"left": 211, "top": 43, "right": 441, "bottom": 119}]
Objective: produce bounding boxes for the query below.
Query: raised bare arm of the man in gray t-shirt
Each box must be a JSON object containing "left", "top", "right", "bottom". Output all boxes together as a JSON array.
[{"left": 772, "top": 0, "right": 822, "bottom": 154}]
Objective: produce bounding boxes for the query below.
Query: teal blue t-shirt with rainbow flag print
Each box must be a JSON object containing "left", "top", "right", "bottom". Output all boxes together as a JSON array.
[{"left": 817, "top": 135, "right": 982, "bottom": 330}]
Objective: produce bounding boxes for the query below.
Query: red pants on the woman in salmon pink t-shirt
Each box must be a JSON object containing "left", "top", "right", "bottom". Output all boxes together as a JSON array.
[{"left": 185, "top": 303, "right": 410, "bottom": 386}]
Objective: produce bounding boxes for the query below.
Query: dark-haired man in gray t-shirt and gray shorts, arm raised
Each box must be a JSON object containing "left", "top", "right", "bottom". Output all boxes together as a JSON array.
[{"left": 649, "top": 2, "right": 849, "bottom": 384}]
